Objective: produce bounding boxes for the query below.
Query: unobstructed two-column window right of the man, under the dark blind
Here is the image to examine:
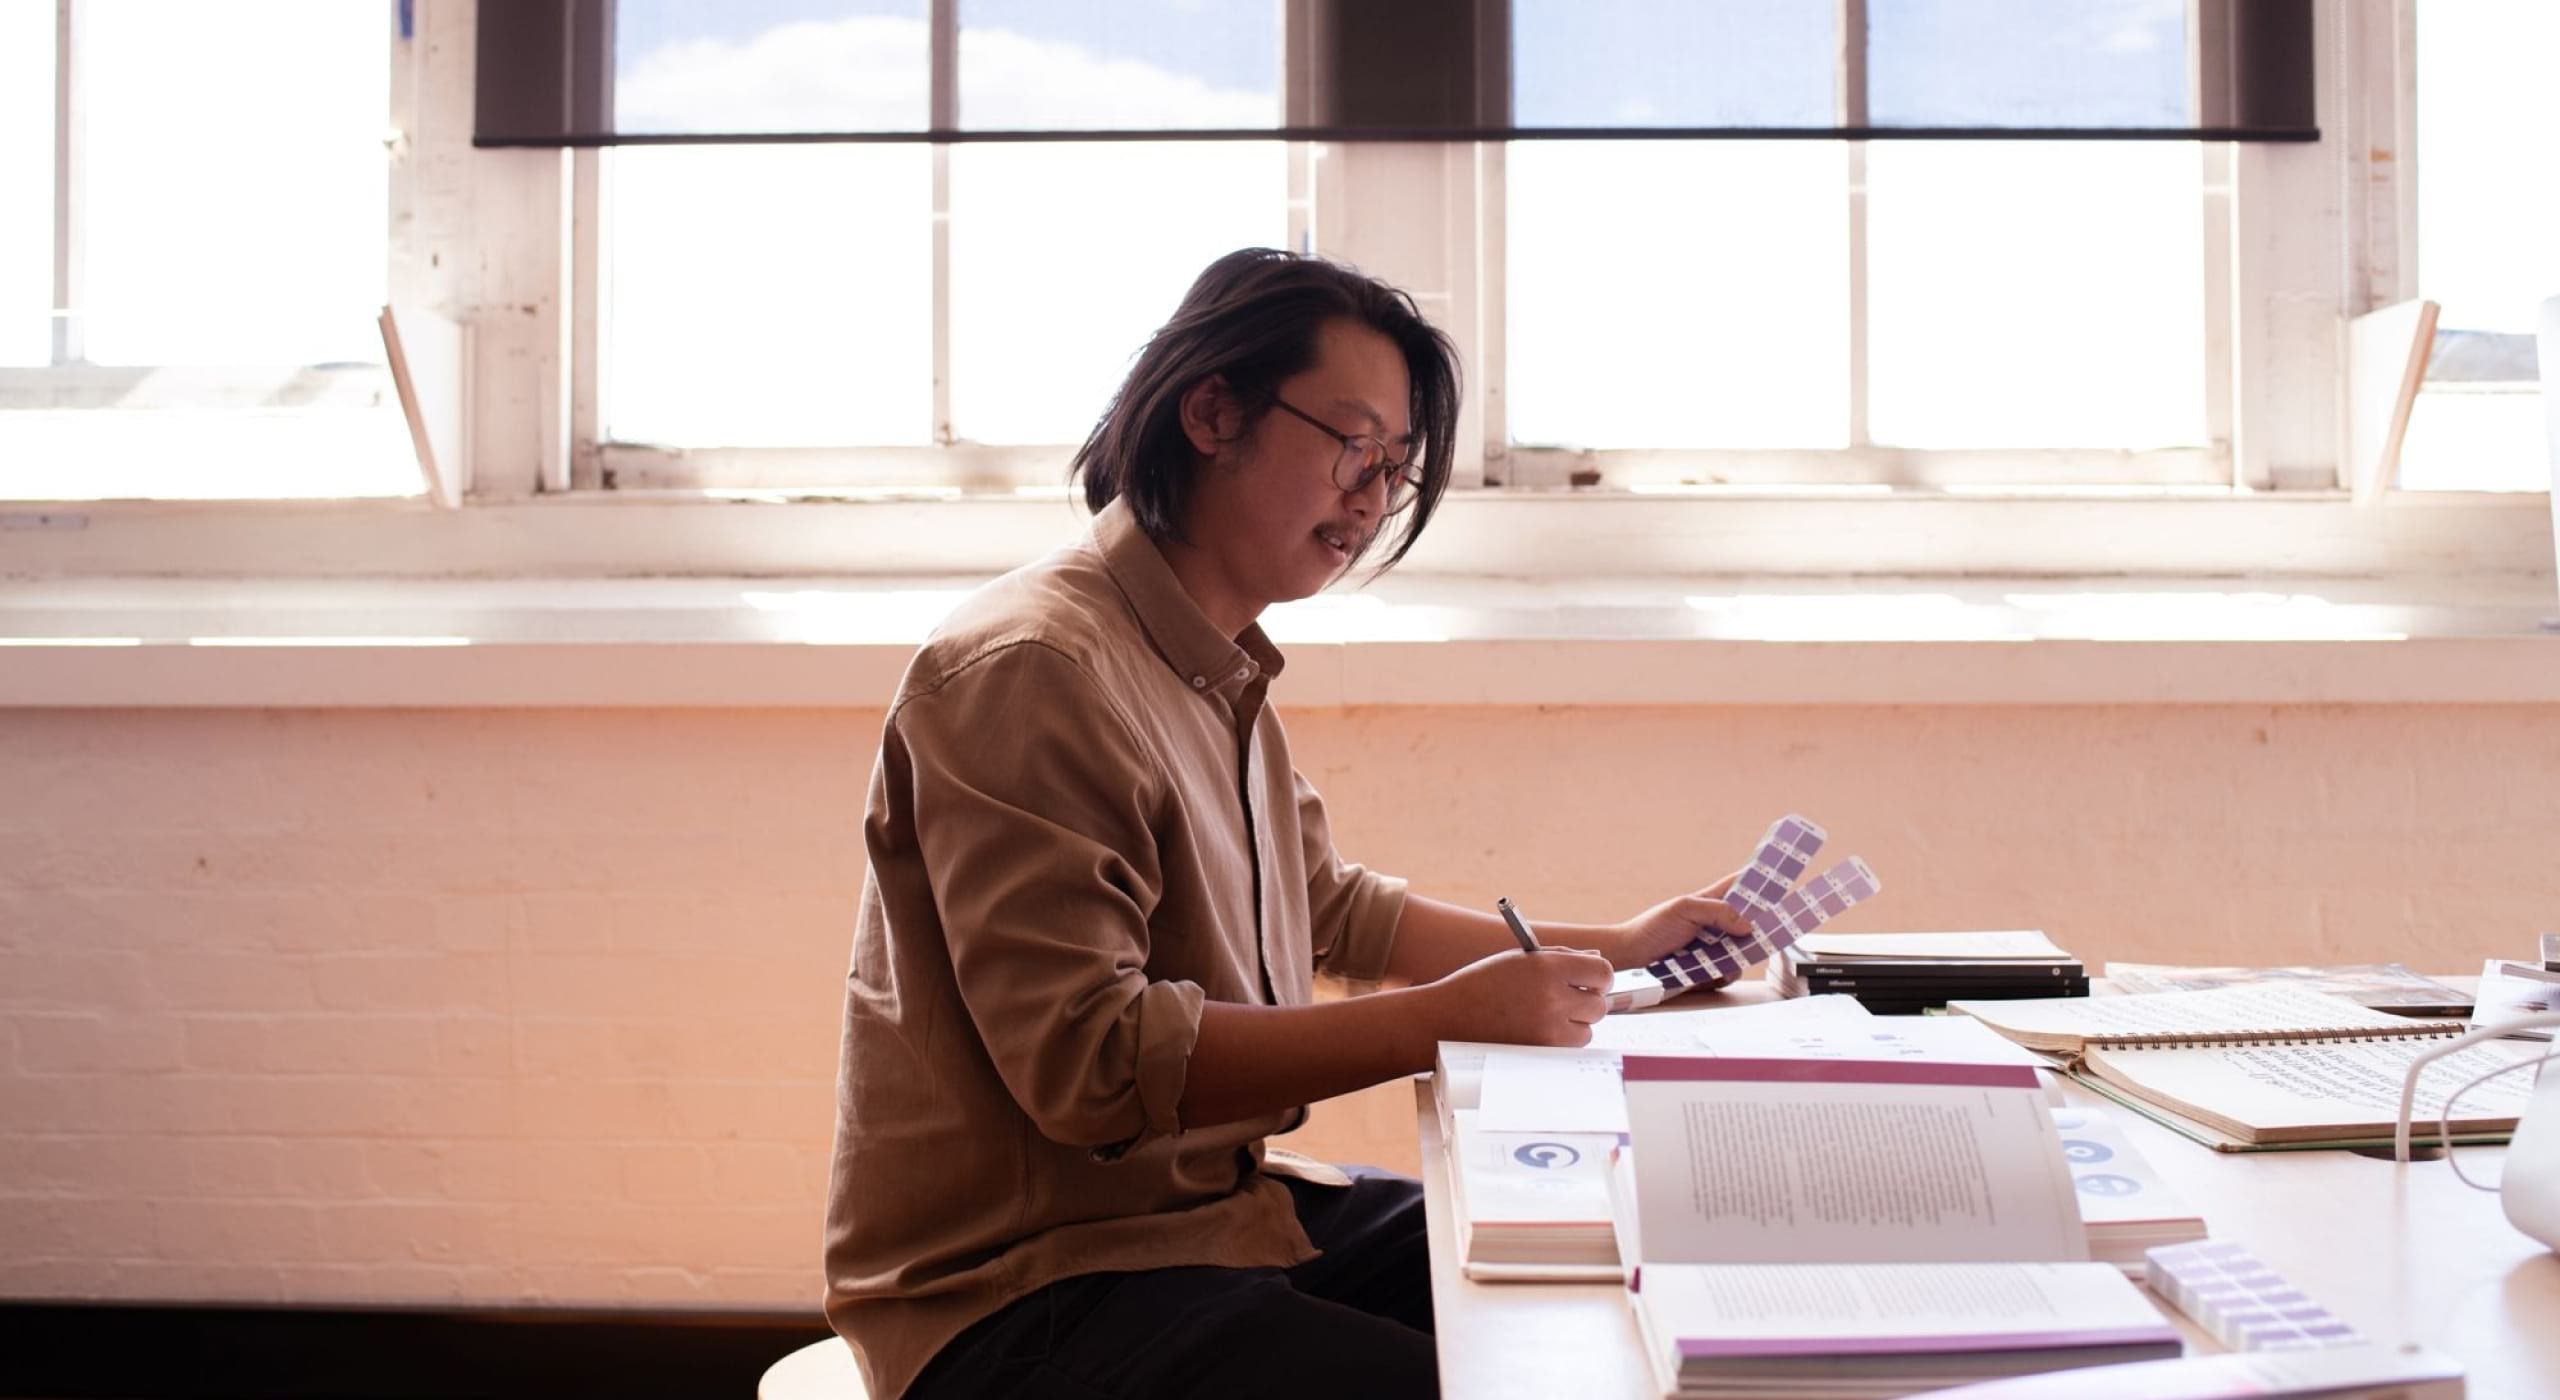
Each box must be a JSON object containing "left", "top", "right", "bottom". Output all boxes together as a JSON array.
[{"left": 1503, "top": 0, "right": 2230, "bottom": 484}]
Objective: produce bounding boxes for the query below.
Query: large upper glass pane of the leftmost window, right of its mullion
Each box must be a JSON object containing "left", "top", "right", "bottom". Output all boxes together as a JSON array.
[{"left": 77, "top": 0, "right": 392, "bottom": 366}]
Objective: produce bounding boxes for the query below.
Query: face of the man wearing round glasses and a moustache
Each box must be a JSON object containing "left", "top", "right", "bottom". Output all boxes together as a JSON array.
[{"left": 1188, "top": 320, "right": 1413, "bottom": 612}]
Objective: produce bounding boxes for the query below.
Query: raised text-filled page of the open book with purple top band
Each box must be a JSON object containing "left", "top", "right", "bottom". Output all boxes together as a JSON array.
[{"left": 1626, "top": 1060, "right": 2089, "bottom": 1267}]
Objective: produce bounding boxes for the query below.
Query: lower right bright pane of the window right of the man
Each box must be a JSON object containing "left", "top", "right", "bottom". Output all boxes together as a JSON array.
[{"left": 1866, "top": 141, "right": 2204, "bottom": 448}]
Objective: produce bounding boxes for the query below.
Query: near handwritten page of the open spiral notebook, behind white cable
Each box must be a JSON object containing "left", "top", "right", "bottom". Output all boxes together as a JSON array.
[{"left": 2089, "top": 1037, "right": 2545, "bottom": 1136}]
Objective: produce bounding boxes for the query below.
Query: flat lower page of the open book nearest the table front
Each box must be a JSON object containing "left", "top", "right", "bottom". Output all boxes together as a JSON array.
[{"left": 1636, "top": 1262, "right": 2179, "bottom": 1356}]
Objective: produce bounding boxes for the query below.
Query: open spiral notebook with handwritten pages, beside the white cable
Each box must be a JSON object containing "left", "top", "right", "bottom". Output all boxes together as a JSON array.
[{"left": 1951, "top": 983, "right": 2545, "bottom": 1152}]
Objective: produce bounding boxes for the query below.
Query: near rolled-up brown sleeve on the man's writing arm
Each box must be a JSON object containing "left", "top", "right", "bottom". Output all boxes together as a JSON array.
[{"left": 888, "top": 642, "right": 1201, "bottom": 1157}]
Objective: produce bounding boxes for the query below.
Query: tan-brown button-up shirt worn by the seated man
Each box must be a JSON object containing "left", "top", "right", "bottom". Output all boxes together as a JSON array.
[{"left": 827, "top": 504, "right": 1405, "bottom": 1400}]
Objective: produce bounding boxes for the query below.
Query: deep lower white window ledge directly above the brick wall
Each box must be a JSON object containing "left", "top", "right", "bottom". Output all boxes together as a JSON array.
[{"left": 0, "top": 576, "right": 2560, "bottom": 709}]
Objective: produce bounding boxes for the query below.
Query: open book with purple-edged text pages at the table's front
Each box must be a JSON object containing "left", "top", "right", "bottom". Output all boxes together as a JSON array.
[{"left": 1610, "top": 1054, "right": 2179, "bottom": 1397}]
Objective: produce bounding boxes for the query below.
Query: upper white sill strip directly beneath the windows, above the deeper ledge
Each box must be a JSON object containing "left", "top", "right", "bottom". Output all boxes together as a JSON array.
[{"left": 0, "top": 489, "right": 2552, "bottom": 586}]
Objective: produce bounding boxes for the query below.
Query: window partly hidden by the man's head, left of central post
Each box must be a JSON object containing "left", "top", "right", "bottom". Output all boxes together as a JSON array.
[{"left": 602, "top": 0, "right": 1288, "bottom": 489}]
